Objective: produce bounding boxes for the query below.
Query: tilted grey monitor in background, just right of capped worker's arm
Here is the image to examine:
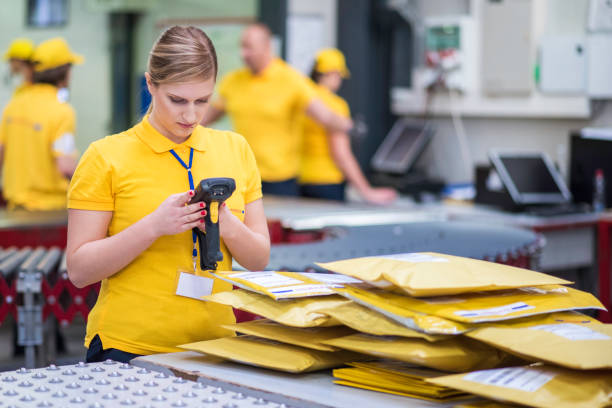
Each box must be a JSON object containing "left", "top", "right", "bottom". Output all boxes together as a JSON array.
[{"left": 371, "top": 118, "right": 433, "bottom": 174}]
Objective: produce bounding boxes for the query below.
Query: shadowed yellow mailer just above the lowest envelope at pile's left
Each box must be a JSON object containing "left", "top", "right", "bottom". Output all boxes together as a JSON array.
[{"left": 223, "top": 319, "right": 355, "bottom": 351}]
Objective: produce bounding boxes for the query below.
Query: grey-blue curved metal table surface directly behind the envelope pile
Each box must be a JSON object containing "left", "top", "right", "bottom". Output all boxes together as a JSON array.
[{"left": 267, "top": 221, "right": 541, "bottom": 271}]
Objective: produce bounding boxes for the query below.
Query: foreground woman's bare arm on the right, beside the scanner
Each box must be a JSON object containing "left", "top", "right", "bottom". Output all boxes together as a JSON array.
[{"left": 219, "top": 199, "right": 270, "bottom": 271}]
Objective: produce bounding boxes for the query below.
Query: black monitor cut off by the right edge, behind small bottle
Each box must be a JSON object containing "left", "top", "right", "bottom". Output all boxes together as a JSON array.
[{"left": 569, "top": 133, "right": 612, "bottom": 205}]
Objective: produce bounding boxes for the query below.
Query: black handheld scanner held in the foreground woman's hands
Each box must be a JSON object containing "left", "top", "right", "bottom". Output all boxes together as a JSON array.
[{"left": 189, "top": 177, "right": 236, "bottom": 270}]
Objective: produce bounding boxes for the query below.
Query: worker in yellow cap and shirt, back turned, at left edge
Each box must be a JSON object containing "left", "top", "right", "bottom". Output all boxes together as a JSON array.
[{"left": 0, "top": 37, "right": 83, "bottom": 210}]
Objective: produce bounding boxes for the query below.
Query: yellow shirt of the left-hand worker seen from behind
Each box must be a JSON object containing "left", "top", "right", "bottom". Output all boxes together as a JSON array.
[{"left": 0, "top": 84, "right": 76, "bottom": 210}]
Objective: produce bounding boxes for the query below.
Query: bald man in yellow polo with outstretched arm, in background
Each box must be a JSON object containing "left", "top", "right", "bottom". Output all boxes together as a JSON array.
[{"left": 202, "top": 24, "right": 352, "bottom": 196}]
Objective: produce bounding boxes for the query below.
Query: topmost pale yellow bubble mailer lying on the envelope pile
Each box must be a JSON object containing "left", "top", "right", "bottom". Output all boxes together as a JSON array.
[{"left": 317, "top": 252, "right": 572, "bottom": 297}]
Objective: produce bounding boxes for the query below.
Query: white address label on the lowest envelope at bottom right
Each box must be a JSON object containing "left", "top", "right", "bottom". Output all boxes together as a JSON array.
[{"left": 463, "top": 367, "right": 555, "bottom": 392}]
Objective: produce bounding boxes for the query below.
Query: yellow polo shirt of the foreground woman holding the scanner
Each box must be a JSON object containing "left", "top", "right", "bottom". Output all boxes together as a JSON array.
[{"left": 68, "top": 118, "right": 262, "bottom": 354}]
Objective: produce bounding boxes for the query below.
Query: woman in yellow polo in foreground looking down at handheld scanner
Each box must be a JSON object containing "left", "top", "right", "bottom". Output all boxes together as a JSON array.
[{"left": 66, "top": 26, "right": 270, "bottom": 362}]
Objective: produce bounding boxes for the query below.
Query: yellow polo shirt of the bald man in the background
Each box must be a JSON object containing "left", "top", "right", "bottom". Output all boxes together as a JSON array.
[{"left": 215, "top": 58, "right": 314, "bottom": 182}]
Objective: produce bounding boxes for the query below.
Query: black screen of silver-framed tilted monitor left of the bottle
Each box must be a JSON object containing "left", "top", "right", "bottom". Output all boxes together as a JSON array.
[{"left": 500, "top": 157, "right": 561, "bottom": 194}]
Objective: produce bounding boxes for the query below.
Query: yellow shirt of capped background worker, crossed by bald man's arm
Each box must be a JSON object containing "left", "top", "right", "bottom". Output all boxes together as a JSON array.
[{"left": 299, "top": 84, "right": 350, "bottom": 184}]
